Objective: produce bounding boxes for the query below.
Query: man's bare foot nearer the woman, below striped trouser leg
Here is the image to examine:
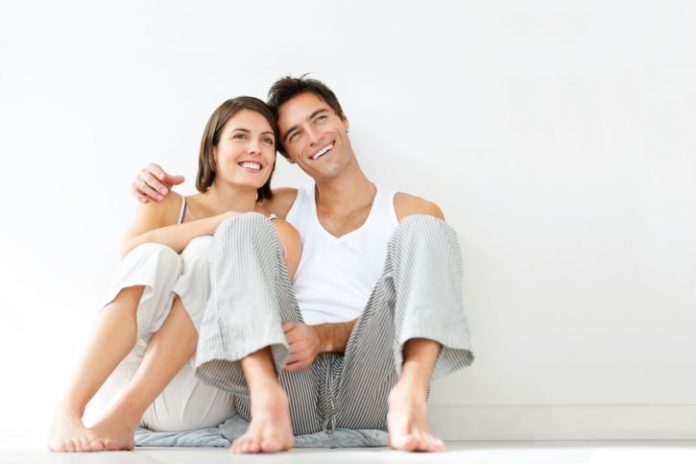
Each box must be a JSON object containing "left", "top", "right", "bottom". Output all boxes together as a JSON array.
[{"left": 231, "top": 386, "right": 295, "bottom": 453}]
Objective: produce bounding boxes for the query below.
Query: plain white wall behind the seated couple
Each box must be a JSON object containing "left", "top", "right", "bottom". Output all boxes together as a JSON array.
[{"left": 0, "top": 0, "right": 696, "bottom": 442}]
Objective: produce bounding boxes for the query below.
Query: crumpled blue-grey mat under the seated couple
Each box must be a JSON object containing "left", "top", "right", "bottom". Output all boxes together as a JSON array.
[{"left": 135, "top": 416, "right": 387, "bottom": 448}]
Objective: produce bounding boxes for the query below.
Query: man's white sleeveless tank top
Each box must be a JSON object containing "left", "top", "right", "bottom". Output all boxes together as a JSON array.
[{"left": 286, "top": 184, "right": 399, "bottom": 325}]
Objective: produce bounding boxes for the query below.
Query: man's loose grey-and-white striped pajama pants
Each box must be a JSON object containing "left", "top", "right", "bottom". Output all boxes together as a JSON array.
[{"left": 196, "top": 213, "right": 473, "bottom": 435}]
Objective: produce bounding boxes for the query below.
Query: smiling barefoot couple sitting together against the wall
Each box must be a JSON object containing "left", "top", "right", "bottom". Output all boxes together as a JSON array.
[{"left": 49, "top": 77, "right": 473, "bottom": 453}]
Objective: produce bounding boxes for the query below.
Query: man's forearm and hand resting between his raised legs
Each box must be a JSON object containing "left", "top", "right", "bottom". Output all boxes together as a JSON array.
[{"left": 283, "top": 319, "right": 357, "bottom": 371}]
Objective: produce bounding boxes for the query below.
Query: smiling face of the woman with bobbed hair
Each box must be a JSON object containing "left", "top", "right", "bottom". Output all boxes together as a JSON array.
[{"left": 213, "top": 110, "right": 276, "bottom": 189}]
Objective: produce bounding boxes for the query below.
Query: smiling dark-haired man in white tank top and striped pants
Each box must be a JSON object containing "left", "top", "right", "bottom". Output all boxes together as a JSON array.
[{"left": 133, "top": 76, "right": 473, "bottom": 453}]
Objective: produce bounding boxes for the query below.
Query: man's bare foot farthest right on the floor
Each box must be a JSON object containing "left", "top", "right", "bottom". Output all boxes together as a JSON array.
[{"left": 387, "top": 384, "right": 445, "bottom": 451}]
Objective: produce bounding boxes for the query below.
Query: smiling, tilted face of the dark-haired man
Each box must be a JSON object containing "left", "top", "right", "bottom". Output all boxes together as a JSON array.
[{"left": 278, "top": 92, "right": 354, "bottom": 182}]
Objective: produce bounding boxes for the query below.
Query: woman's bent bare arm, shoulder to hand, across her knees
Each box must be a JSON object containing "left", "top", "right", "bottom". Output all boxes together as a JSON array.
[{"left": 121, "top": 192, "right": 238, "bottom": 256}]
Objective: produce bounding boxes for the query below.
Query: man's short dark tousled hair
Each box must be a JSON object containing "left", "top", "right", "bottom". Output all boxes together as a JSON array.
[{"left": 268, "top": 74, "right": 344, "bottom": 157}]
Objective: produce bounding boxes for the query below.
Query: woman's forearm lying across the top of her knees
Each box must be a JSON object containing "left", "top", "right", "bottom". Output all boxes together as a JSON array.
[{"left": 121, "top": 213, "right": 238, "bottom": 256}]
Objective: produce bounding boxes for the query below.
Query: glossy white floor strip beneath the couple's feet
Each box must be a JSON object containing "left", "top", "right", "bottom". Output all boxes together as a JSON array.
[{"left": 0, "top": 441, "right": 696, "bottom": 464}]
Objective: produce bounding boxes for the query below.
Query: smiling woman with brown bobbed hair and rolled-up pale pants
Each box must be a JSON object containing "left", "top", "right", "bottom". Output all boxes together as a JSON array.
[{"left": 49, "top": 97, "right": 301, "bottom": 451}]
